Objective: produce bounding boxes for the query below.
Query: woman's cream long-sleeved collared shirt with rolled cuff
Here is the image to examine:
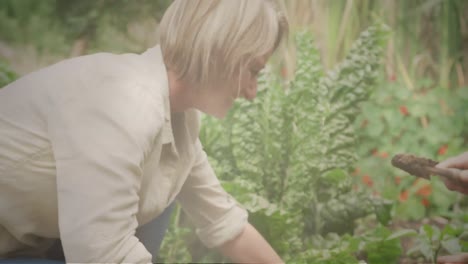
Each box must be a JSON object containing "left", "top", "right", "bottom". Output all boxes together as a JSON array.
[{"left": 0, "top": 47, "right": 247, "bottom": 263}]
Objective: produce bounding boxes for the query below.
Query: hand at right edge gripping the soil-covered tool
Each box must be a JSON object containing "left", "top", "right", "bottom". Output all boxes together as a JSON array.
[{"left": 436, "top": 152, "right": 468, "bottom": 195}]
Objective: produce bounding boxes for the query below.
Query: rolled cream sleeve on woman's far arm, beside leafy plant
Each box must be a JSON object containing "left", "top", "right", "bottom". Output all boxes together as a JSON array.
[{"left": 178, "top": 140, "right": 248, "bottom": 248}]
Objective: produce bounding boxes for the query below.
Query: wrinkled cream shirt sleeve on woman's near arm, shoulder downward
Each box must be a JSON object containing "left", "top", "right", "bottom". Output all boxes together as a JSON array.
[{"left": 48, "top": 75, "right": 163, "bottom": 263}]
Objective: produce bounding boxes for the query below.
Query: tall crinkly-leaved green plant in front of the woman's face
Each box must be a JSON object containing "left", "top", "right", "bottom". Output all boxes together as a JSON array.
[{"left": 162, "top": 24, "right": 391, "bottom": 262}]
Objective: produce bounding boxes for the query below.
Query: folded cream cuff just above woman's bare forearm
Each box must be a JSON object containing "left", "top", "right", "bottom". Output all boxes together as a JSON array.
[{"left": 196, "top": 205, "right": 248, "bottom": 248}]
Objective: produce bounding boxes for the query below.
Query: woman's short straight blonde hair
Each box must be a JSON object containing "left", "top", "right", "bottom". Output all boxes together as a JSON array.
[{"left": 159, "top": 0, "right": 288, "bottom": 87}]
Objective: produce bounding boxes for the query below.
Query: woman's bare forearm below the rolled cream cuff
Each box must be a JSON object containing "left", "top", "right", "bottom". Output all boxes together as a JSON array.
[{"left": 220, "top": 224, "right": 284, "bottom": 263}]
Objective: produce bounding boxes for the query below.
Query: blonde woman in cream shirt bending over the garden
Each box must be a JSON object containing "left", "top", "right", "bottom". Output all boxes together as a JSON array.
[{"left": 0, "top": 0, "right": 287, "bottom": 263}]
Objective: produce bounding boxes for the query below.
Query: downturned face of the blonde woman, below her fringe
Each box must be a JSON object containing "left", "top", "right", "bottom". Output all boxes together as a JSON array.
[{"left": 198, "top": 56, "right": 269, "bottom": 118}]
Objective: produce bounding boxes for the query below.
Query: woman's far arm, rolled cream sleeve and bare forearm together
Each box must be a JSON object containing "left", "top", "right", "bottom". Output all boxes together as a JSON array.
[{"left": 178, "top": 141, "right": 283, "bottom": 263}]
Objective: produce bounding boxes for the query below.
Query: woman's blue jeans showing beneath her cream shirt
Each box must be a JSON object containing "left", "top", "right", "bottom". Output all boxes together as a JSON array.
[{"left": 0, "top": 203, "right": 175, "bottom": 264}]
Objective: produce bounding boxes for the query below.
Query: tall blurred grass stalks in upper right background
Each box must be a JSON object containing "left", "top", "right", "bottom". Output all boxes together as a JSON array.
[{"left": 283, "top": 0, "right": 468, "bottom": 89}]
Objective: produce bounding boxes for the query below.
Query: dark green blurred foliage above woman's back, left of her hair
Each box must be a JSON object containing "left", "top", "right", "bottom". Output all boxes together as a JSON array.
[{"left": 0, "top": 0, "right": 170, "bottom": 56}]
